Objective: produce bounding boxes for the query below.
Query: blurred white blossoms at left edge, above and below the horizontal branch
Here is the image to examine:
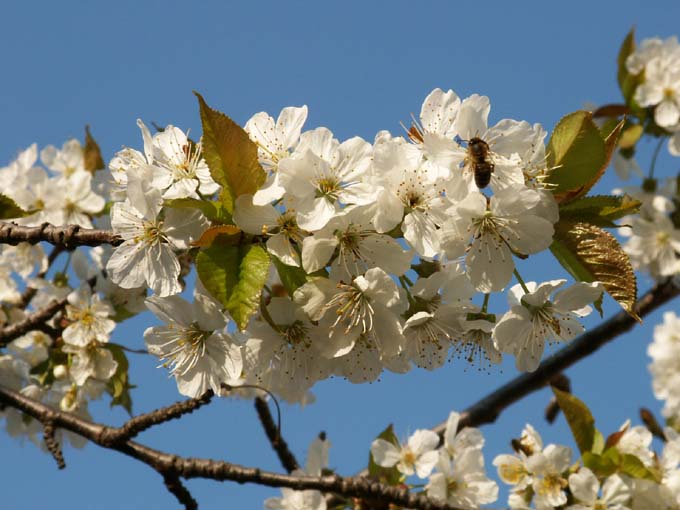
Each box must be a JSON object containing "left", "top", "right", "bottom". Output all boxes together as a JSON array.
[{"left": 0, "top": 140, "right": 138, "bottom": 446}]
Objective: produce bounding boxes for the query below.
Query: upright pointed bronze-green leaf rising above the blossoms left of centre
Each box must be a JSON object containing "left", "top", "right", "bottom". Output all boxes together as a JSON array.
[{"left": 194, "top": 92, "right": 266, "bottom": 213}]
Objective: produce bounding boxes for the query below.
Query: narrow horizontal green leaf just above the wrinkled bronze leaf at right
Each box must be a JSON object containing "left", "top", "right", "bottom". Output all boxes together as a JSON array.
[{"left": 560, "top": 195, "right": 641, "bottom": 227}]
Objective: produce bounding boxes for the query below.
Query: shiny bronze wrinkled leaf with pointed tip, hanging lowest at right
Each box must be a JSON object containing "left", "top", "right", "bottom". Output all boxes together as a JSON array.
[{"left": 550, "top": 221, "right": 640, "bottom": 320}]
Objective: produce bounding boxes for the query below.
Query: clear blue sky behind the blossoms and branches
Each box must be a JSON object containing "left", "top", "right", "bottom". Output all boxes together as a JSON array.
[{"left": 0, "top": 0, "right": 680, "bottom": 510}]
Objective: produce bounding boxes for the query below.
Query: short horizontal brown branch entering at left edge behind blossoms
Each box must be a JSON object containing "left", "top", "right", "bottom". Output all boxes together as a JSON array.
[{"left": 0, "top": 221, "right": 123, "bottom": 249}]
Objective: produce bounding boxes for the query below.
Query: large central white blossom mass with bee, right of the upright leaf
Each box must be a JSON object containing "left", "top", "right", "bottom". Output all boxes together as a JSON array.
[{"left": 227, "top": 89, "right": 602, "bottom": 400}]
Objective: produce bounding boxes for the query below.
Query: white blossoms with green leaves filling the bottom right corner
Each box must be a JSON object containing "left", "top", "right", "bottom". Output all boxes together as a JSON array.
[{"left": 493, "top": 422, "right": 680, "bottom": 510}]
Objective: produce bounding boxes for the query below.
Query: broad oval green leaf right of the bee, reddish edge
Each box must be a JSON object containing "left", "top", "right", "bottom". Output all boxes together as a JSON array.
[{"left": 547, "top": 111, "right": 606, "bottom": 201}]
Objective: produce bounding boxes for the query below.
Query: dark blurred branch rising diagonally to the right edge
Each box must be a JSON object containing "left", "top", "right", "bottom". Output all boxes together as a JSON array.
[{"left": 433, "top": 280, "right": 680, "bottom": 435}]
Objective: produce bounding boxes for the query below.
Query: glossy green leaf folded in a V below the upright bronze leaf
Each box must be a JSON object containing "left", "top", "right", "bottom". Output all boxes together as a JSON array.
[{"left": 196, "top": 244, "right": 269, "bottom": 330}]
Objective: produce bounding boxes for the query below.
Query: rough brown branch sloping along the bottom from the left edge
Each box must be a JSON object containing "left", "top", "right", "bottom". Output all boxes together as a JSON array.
[{"left": 0, "top": 386, "right": 468, "bottom": 510}]
